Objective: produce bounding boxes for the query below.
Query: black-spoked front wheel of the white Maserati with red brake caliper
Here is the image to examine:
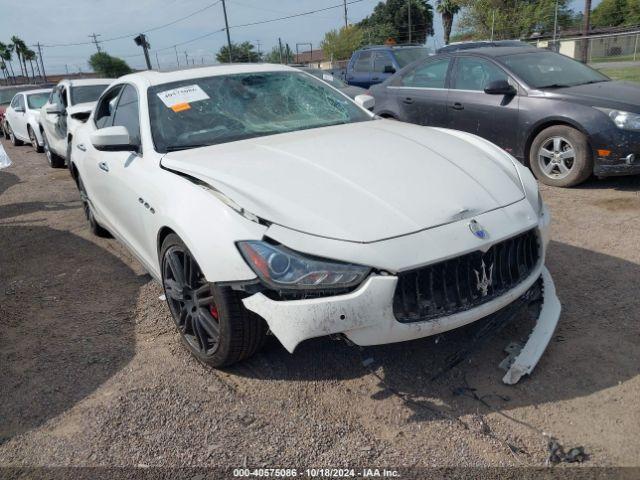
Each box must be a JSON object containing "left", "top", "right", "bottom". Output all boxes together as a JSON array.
[{"left": 160, "top": 234, "right": 267, "bottom": 368}]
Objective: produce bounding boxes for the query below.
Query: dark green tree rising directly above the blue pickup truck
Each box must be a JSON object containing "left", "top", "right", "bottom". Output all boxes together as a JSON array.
[{"left": 358, "top": 0, "right": 433, "bottom": 44}]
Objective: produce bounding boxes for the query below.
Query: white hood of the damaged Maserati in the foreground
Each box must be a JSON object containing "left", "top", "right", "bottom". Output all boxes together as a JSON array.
[{"left": 161, "top": 120, "right": 524, "bottom": 242}]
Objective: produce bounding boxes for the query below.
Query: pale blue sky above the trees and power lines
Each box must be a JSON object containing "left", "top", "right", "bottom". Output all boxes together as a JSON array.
[{"left": 0, "top": 0, "right": 599, "bottom": 73}]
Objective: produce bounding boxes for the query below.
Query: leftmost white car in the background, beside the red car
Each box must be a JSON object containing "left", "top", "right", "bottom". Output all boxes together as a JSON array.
[{"left": 4, "top": 88, "right": 51, "bottom": 152}]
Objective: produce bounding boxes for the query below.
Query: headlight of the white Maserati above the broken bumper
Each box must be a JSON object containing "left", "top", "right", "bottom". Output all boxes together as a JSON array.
[{"left": 238, "top": 240, "right": 371, "bottom": 290}]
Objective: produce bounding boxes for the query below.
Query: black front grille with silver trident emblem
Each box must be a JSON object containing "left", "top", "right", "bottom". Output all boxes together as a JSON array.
[{"left": 393, "top": 230, "right": 540, "bottom": 323}]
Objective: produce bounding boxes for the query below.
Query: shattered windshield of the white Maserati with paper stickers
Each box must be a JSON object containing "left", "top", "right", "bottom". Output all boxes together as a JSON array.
[{"left": 147, "top": 71, "right": 373, "bottom": 153}]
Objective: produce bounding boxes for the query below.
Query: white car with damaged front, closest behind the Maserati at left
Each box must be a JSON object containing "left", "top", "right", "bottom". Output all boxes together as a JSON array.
[{"left": 40, "top": 78, "right": 113, "bottom": 168}]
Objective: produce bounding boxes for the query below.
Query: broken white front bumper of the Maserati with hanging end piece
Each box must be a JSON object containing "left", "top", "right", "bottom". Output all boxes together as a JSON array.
[{"left": 243, "top": 265, "right": 560, "bottom": 384}]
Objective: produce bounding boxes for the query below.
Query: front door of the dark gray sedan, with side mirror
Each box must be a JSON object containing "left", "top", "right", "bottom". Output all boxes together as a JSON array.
[{"left": 447, "top": 56, "right": 519, "bottom": 152}]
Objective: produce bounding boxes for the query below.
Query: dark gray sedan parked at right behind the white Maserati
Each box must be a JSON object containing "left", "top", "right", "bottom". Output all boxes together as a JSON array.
[{"left": 370, "top": 47, "right": 640, "bottom": 187}]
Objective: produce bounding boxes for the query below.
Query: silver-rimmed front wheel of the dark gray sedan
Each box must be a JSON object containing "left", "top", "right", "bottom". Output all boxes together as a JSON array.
[{"left": 529, "top": 125, "right": 593, "bottom": 187}]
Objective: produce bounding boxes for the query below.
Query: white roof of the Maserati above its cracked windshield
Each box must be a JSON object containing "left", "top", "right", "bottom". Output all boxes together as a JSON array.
[{"left": 118, "top": 63, "right": 299, "bottom": 87}]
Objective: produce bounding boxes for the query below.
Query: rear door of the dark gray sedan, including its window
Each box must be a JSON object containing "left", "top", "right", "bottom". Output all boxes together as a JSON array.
[{"left": 388, "top": 57, "right": 451, "bottom": 127}]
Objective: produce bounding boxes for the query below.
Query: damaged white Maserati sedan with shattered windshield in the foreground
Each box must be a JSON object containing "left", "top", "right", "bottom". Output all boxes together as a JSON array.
[{"left": 71, "top": 64, "right": 560, "bottom": 383}]
